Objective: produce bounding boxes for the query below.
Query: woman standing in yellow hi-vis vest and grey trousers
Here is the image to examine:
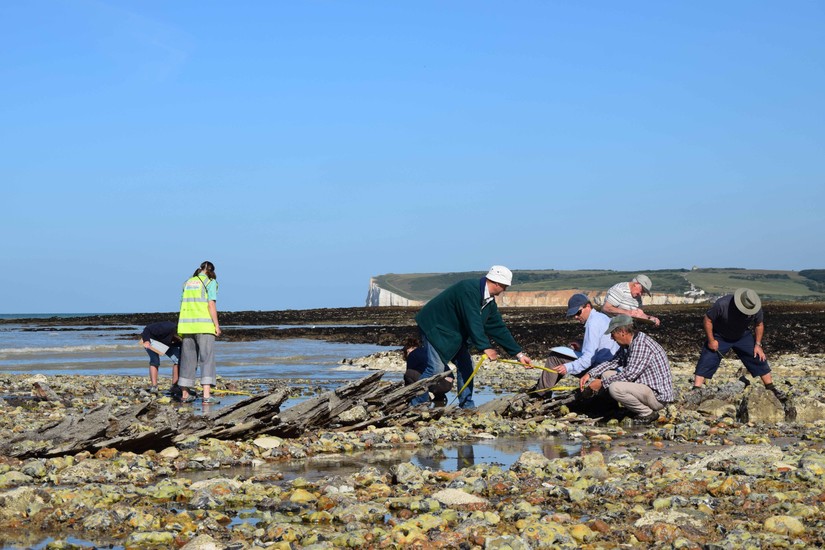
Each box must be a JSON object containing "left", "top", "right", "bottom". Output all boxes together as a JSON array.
[{"left": 178, "top": 262, "right": 221, "bottom": 404}]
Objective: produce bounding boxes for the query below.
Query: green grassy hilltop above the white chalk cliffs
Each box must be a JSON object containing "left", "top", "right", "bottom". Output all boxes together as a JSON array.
[{"left": 374, "top": 267, "right": 825, "bottom": 301}]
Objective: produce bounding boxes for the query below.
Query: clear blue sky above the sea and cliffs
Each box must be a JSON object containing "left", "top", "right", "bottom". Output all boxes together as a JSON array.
[{"left": 0, "top": 0, "right": 825, "bottom": 313}]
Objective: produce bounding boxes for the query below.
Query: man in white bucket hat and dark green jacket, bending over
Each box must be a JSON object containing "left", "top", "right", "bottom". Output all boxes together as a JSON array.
[{"left": 410, "top": 265, "right": 532, "bottom": 409}]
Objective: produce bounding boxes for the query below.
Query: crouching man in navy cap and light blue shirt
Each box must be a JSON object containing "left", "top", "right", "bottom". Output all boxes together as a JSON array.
[{"left": 535, "top": 294, "right": 619, "bottom": 397}]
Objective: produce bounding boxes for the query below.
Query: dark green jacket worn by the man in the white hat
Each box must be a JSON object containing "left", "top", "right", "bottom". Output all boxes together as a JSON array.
[{"left": 415, "top": 279, "right": 521, "bottom": 364}]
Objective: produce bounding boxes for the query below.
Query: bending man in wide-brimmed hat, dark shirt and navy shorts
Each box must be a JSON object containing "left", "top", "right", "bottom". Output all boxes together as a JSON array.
[{"left": 693, "top": 288, "right": 787, "bottom": 401}]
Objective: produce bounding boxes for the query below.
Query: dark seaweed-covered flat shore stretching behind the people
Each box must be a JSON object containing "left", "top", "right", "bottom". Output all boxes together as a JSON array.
[{"left": 0, "top": 302, "right": 825, "bottom": 361}]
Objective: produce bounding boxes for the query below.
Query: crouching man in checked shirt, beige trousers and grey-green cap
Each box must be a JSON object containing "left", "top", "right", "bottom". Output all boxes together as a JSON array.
[{"left": 581, "top": 315, "right": 673, "bottom": 424}]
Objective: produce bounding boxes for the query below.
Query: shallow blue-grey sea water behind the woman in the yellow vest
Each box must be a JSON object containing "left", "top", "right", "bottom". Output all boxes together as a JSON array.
[{"left": 0, "top": 324, "right": 401, "bottom": 383}]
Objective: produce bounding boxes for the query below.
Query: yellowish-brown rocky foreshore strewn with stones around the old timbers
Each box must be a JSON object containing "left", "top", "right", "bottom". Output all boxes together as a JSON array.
[{"left": 0, "top": 353, "right": 825, "bottom": 549}]
